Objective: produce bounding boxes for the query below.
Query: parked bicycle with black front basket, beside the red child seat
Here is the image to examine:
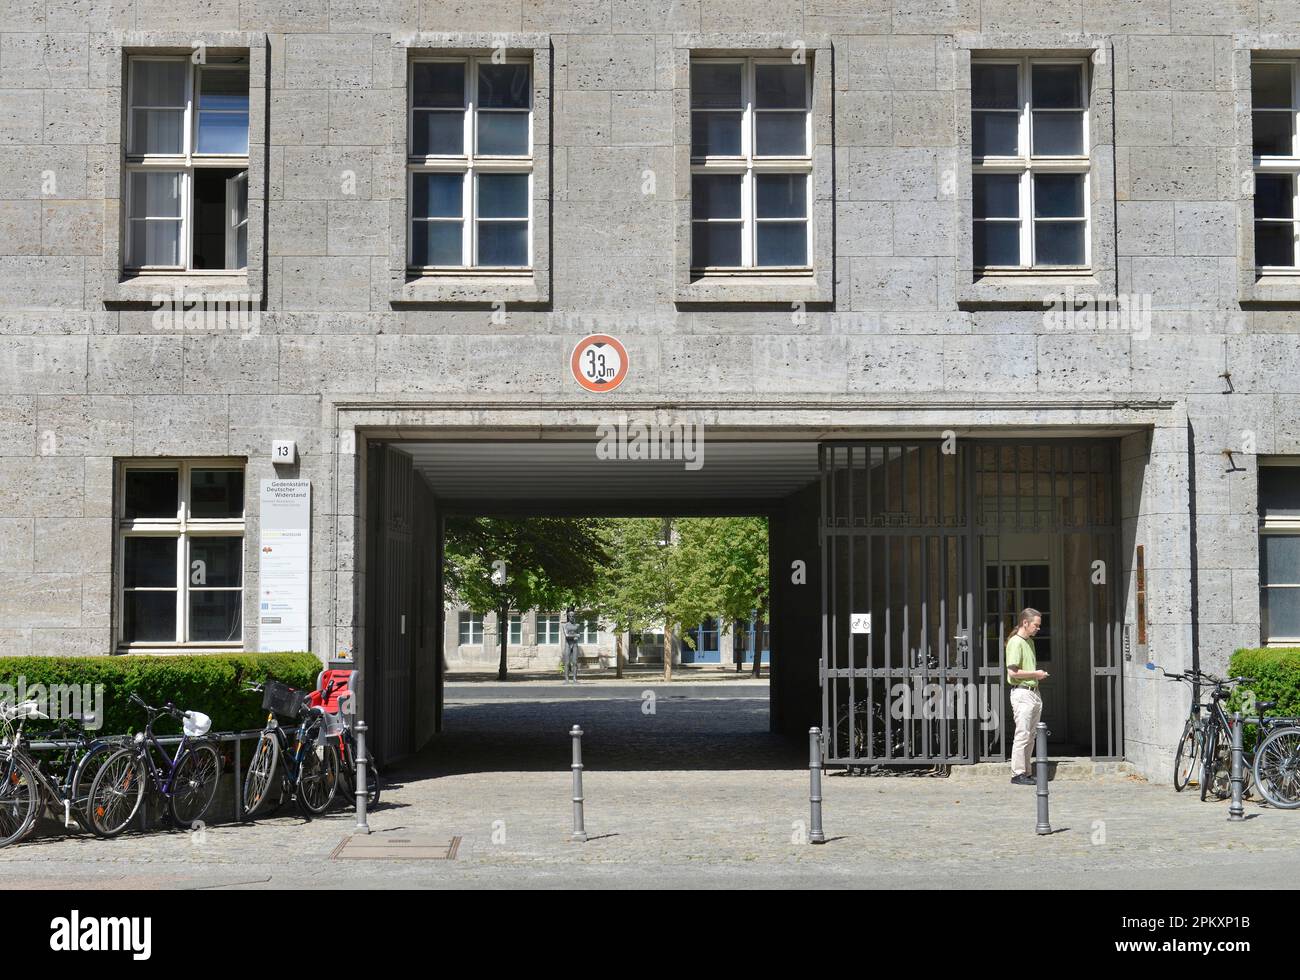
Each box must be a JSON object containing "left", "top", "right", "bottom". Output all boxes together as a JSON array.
[{"left": 243, "top": 681, "right": 339, "bottom": 818}]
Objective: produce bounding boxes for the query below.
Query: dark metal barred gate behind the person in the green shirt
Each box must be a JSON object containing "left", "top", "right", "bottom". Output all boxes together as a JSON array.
[{"left": 820, "top": 439, "right": 1123, "bottom": 766}]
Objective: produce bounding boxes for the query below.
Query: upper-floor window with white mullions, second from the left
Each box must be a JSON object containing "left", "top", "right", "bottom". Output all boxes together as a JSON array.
[{"left": 407, "top": 57, "right": 533, "bottom": 272}]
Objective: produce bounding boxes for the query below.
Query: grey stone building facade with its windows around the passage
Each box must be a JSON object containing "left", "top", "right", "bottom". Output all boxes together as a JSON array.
[{"left": 0, "top": 0, "right": 1300, "bottom": 776}]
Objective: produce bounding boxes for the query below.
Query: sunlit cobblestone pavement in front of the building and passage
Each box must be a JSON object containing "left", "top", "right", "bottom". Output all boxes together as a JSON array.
[{"left": 0, "top": 685, "right": 1300, "bottom": 888}]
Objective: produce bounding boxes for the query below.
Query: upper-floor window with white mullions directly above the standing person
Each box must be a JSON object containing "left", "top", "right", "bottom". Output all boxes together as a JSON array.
[{"left": 971, "top": 58, "right": 1091, "bottom": 270}]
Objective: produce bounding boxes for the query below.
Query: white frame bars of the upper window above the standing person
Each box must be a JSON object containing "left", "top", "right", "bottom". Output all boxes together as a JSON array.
[{"left": 971, "top": 56, "right": 1092, "bottom": 274}]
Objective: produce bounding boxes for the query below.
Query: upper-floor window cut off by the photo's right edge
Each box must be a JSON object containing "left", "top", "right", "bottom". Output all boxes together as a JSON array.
[{"left": 1251, "top": 60, "right": 1300, "bottom": 267}]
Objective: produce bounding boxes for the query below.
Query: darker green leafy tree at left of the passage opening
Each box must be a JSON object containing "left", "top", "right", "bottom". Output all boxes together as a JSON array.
[{"left": 443, "top": 517, "right": 610, "bottom": 681}]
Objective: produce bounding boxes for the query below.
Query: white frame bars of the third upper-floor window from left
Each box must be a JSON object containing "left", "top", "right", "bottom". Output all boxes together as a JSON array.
[{"left": 688, "top": 56, "right": 814, "bottom": 276}]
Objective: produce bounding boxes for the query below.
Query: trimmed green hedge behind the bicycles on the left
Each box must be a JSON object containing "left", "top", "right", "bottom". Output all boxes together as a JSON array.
[{"left": 0, "top": 654, "right": 321, "bottom": 736}]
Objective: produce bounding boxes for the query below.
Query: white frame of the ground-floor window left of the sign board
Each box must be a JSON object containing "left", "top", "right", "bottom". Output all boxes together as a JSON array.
[{"left": 113, "top": 459, "right": 248, "bottom": 650}]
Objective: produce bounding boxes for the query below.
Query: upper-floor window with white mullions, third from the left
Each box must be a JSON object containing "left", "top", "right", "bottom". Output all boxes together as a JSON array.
[{"left": 690, "top": 58, "right": 813, "bottom": 272}]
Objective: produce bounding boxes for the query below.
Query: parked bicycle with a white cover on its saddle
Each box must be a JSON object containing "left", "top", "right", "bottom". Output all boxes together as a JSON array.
[{"left": 88, "top": 694, "right": 221, "bottom": 837}]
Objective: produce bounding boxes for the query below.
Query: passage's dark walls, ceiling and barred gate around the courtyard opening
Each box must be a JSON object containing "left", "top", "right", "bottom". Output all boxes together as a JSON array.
[{"left": 363, "top": 434, "right": 1122, "bottom": 767}]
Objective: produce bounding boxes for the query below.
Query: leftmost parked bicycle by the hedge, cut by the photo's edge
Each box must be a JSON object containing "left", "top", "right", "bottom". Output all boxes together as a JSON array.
[{"left": 0, "top": 701, "right": 121, "bottom": 847}]
